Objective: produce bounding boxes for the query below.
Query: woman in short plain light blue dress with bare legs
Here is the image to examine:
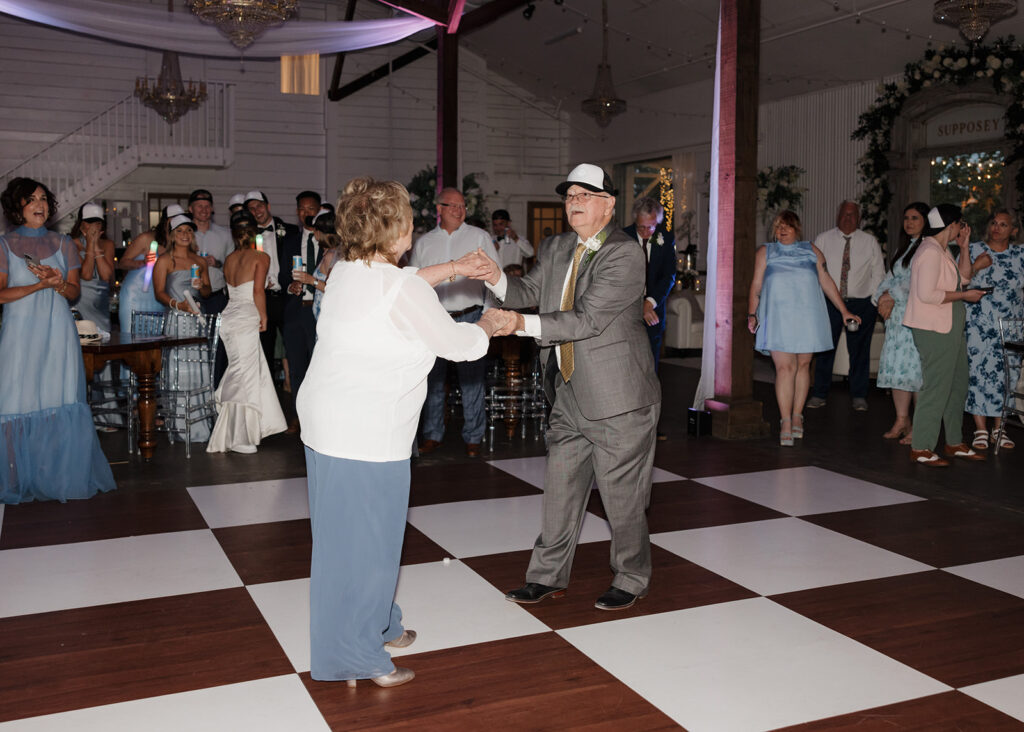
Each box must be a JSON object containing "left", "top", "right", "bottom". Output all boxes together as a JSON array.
[{"left": 746, "top": 210, "right": 860, "bottom": 446}]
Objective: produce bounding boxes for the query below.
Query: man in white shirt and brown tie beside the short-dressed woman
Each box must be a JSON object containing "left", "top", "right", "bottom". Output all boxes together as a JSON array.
[{"left": 795, "top": 201, "right": 886, "bottom": 412}]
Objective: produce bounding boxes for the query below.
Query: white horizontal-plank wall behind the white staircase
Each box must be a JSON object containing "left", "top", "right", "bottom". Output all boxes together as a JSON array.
[{"left": 0, "top": 0, "right": 568, "bottom": 234}]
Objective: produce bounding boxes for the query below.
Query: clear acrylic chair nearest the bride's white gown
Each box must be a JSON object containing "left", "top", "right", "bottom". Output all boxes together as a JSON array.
[{"left": 157, "top": 312, "right": 220, "bottom": 458}]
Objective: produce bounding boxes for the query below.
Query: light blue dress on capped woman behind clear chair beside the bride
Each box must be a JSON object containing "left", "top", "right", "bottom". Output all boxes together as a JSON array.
[{"left": 160, "top": 269, "right": 216, "bottom": 442}]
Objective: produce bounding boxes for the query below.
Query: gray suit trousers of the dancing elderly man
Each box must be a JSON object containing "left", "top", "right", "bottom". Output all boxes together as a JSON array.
[{"left": 526, "top": 376, "right": 662, "bottom": 595}]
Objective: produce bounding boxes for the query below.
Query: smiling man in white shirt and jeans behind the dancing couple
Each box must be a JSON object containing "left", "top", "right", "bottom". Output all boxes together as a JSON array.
[{"left": 409, "top": 188, "right": 498, "bottom": 458}]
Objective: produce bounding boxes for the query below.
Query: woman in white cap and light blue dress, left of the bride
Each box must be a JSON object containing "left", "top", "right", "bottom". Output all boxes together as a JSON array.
[{"left": 153, "top": 214, "right": 214, "bottom": 442}]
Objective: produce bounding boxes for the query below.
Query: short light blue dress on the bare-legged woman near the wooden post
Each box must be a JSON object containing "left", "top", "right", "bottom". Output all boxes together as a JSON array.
[{"left": 755, "top": 242, "right": 833, "bottom": 354}]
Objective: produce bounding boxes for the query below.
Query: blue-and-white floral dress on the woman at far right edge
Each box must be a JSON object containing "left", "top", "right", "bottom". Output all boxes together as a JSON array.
[{"left": 965, "top": 242, "right": 1024, "bottom": 417}]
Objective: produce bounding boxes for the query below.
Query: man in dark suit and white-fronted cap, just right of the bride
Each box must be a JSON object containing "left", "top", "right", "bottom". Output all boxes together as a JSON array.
[{"left": 245, "top": 190, "right": 305, "bottom": 433}]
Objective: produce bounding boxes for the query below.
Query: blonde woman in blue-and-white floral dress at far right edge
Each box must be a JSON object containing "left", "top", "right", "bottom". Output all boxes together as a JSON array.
[{"left": 966, "top": 210, "right": 1024, "bottom": 449}]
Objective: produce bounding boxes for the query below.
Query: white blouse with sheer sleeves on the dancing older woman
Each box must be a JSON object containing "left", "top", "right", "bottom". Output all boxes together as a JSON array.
[{"left": 295, "top": 261, "right": 487, "bottom": 463}]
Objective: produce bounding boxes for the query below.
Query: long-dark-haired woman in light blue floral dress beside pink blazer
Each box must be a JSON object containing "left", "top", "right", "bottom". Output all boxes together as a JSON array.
[{"left": 874, "top": 201, "right": 931, "bottom": 444}]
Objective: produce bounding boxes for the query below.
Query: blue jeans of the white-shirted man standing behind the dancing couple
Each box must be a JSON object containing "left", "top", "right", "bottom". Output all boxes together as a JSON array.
[{"left": 423, "top": 310, "right": 487, "bottom": 444}]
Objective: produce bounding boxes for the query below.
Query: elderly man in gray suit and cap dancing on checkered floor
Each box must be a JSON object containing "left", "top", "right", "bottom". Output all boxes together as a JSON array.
[{"left": 475, "top": 163, "right": 662, "bottom": 610}]
